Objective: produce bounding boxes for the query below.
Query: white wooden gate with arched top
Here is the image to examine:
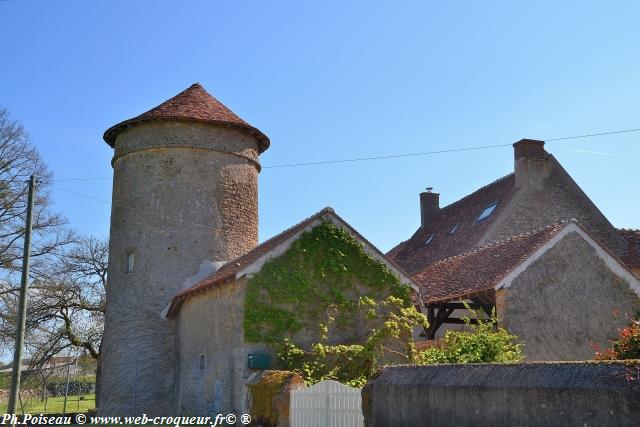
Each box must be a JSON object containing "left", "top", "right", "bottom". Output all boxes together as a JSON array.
[{"left": 289, "top": 380, "right": 364, "bottom": 427}]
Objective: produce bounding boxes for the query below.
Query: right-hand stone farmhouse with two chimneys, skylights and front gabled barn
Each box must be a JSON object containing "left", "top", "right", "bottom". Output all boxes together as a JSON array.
[{"left": 387, "top": 139, "right": 640, "bottom": 360}]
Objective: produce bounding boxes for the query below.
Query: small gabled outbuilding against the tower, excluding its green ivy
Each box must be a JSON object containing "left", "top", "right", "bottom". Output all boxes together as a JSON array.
[{"left": 162, "top": 208, "right": 417, "bottom": 413}]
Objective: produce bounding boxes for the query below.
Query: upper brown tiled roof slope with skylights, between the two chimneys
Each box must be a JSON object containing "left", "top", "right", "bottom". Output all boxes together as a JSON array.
[{"left": 387, "top": 174, "right": 515, "bottom": 272}]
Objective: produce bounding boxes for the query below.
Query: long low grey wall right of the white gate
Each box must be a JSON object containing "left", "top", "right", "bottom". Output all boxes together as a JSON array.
[{"left": 362, "top": 360, "right": 640, "bottom": 427}]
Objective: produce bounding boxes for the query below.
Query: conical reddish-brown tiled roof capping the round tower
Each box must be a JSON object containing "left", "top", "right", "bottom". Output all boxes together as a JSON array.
[{"left": 103, "top": 83, "right": 269, "bottom": 152}]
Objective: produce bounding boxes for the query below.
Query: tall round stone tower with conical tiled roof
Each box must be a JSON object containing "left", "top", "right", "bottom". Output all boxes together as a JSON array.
[{"left": 99, "top": 83, "right": 269, "bottom": 415}]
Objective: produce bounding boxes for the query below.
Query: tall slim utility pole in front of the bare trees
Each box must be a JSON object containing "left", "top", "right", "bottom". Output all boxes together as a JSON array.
[{"left": 7, "top": 175, "right": 36, "bottom": 415}]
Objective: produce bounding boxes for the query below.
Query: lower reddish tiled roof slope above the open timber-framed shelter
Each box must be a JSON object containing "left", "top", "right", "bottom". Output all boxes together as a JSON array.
[{"left": 413, "top": 222, "right": 567, "bottom": 304}]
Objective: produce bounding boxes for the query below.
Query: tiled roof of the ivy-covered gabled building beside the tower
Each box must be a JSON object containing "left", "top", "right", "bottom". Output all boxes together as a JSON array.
[{"left": 167, "top": 207, "right": 415, "bottom": 317}]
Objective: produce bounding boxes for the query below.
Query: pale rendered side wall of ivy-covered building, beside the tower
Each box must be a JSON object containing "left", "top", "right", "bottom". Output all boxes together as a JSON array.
[{"left": 178, "top": 278, "right": 266, "bottom": 416}]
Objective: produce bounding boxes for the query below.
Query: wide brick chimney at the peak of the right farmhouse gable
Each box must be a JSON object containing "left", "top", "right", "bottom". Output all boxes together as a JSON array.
[{"left": 513, "top": 139, "right": 550, "bottom": 190}]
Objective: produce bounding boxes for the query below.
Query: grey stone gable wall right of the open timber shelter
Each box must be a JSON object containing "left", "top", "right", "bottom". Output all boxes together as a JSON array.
[{"left": 497, "top": 232, "right": 640, "bottom": 360}]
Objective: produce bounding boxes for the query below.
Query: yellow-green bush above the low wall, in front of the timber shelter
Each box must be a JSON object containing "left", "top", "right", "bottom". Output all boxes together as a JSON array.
[{"left": 416, "top": 310, "right": 524, "bottom": 365}]
